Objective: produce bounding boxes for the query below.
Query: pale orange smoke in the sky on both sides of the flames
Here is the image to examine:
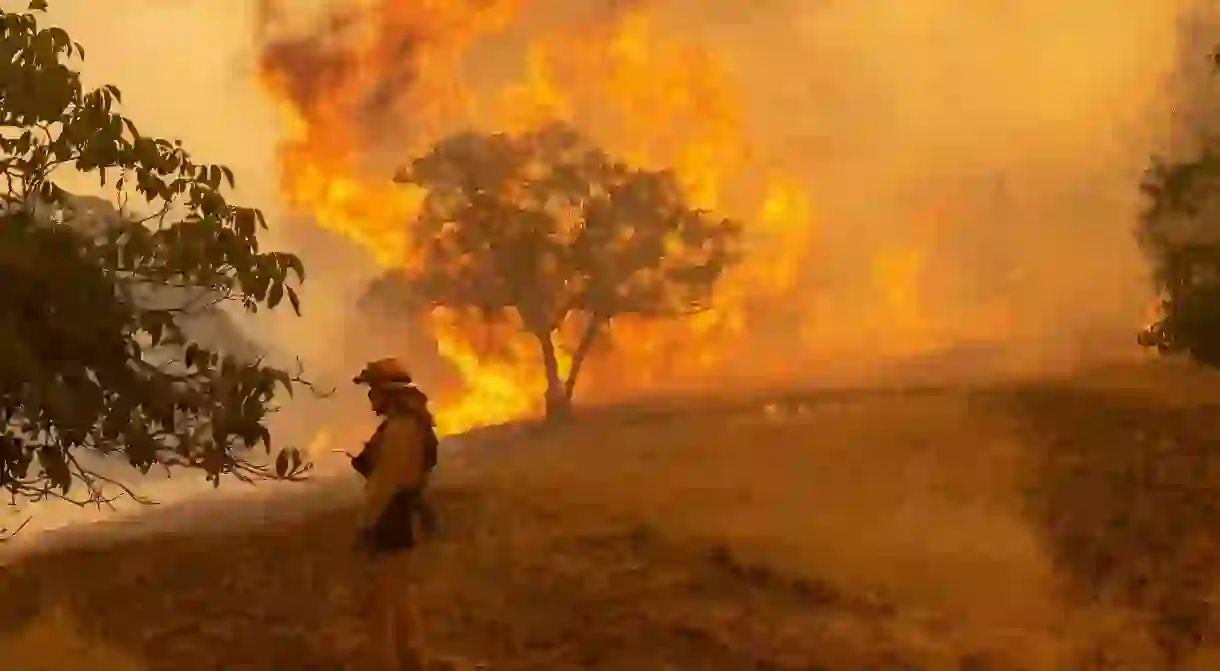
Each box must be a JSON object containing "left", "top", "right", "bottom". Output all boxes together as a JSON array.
[{"left": 6, "top": 0, "right": 1205, "bottom": 442}]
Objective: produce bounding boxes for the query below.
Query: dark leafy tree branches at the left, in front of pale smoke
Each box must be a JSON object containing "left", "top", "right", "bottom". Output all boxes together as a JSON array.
[{"left": 0, "top": 1, "right": 307, "bottom": 536}]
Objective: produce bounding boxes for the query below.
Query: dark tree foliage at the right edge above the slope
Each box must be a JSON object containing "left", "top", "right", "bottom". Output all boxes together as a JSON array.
[{"left": 1137, "top": 48, "right": 1220, "bottom": 367}]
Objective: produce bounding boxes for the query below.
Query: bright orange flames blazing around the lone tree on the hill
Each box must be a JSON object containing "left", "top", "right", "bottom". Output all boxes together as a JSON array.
[{"left": 261, "top": 0, "right": 924, "bottom": 433}]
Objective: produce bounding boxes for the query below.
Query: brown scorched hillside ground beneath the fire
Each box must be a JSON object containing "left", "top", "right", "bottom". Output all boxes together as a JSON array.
[{"left": 0, "top": 367, "right": 1220, "bottom": 671}]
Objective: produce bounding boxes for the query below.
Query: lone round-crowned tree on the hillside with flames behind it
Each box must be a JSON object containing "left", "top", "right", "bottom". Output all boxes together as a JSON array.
[{"left": 370, "top": 123, "right": 742, "bottom": 417}]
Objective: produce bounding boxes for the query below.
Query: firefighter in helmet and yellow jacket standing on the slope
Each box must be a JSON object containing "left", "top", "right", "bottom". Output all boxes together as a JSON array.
[{"left": 351, "top": 359, "right": 437, "bottom": 671}]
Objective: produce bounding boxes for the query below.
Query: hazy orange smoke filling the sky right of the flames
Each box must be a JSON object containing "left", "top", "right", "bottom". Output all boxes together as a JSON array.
[{"left": 247, "top": 0, "right": 1182, "bottom": 400}]
